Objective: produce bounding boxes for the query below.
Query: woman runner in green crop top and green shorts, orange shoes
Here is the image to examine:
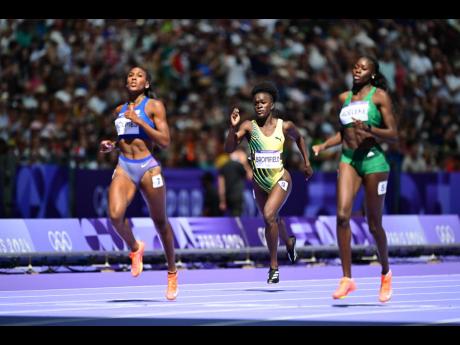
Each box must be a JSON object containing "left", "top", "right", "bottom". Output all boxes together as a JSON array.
[{"left": 313, "top": 56, "right": 398, "bottom": 302}]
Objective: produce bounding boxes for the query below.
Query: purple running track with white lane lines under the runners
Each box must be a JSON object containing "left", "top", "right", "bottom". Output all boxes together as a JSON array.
[{"left": 0, "top": 262, "right": 460, "bottom": 326}]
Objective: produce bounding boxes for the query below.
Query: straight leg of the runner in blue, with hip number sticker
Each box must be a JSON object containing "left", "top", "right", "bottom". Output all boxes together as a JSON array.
[{"left": 140, "top": 167, "right": 176, "bottom": 272}]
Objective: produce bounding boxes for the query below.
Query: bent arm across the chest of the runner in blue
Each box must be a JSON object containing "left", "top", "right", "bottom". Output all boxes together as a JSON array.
[{"left": 125, "top": 99, "right": 171, "bottom": 149}]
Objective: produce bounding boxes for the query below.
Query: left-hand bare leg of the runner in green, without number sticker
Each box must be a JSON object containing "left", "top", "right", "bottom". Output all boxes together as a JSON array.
[{"left": 337, "top": 162, "right": 361, "bottom": 278}]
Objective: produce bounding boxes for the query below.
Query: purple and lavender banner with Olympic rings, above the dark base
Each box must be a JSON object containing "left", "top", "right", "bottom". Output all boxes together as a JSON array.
[{"left": 0, "top": 215, "right": 460, "bottom": 253}]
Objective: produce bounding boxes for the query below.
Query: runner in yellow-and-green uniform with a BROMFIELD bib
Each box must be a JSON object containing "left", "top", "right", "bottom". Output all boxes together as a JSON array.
[{"left": 225, "top": 82, "right": 313, "bottom": 284}]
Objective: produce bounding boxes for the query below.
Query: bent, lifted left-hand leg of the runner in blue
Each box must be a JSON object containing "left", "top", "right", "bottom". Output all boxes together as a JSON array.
[{"left": 109, "top": 165, "right": 139, "bottom": 252}]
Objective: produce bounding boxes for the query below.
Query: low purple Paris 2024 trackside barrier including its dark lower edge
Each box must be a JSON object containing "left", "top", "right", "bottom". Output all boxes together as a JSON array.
[{"left": 0, "top": 215, "right": 460, "bottom": 267}]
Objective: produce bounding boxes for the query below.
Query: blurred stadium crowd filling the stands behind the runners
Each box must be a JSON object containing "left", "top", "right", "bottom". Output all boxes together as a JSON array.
[{"left": 0, "top": 19, "right": 460, "bottom": 173}]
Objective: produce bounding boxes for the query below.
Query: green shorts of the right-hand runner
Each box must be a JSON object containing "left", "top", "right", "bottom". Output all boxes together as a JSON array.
[{"left": 340, "top": 146, "right": 390, "bottom": 176}]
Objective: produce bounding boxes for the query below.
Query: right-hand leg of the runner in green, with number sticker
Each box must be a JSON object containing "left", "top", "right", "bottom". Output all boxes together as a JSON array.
[{"left": 363, "top": 172, "right": 389, "bottom": 275}]
